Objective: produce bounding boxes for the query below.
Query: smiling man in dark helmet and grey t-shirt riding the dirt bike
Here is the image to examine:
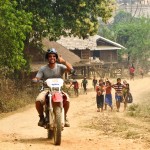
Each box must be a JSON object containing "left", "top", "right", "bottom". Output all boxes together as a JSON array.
[{"left": 32, "top": 48, "right": 73, "bottom": 127}]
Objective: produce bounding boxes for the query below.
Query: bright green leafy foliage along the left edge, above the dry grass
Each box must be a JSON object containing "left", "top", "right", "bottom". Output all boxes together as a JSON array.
[{"left": 0, "top": 0, "right": 32, "bottom": 72}]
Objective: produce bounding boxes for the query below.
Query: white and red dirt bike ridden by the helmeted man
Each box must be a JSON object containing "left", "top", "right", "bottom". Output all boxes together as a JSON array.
[{"left": 44, "top": 78, "right": 65, "bottom": 145}]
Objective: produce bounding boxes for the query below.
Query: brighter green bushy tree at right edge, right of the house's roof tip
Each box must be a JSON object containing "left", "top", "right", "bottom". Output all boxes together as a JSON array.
[{"left": 115, "top": 18, "right": 150, "bottom": 66}]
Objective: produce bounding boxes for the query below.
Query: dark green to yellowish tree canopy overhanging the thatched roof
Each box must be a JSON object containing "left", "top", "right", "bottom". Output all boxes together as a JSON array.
[{"left": 17, "top": 0, "right": 114, "bottom": 40}]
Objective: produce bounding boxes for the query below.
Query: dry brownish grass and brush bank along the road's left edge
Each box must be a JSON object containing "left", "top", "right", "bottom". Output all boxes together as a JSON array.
[{"left": 0, "top": 80, "right": 39, "bottom": 113}]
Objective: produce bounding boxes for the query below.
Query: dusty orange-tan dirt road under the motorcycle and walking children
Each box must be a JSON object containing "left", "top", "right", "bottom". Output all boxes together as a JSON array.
[{"left": 0, "top": 77, "right": 150, "bottom": 150}]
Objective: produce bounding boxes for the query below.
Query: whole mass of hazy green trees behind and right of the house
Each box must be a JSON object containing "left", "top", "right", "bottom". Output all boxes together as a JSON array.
[{"left": 99, "top": 11, "right": 150, "bottom": 68}]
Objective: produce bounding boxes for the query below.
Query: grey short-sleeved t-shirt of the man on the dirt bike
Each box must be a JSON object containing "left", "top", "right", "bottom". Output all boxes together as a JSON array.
[{"left": 36, "top": 63, "right": 66, "bottom": 80}]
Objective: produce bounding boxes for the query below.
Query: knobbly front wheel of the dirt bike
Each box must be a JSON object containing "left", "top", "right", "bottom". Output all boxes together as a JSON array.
[{"left": 54, "top": 106, "right": 62, "bottom": 145}]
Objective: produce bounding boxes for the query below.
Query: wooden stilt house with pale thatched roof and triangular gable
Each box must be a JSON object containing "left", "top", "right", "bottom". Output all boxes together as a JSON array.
[{"left": 57, "top": 35, "right": 125, "bottom": 76}]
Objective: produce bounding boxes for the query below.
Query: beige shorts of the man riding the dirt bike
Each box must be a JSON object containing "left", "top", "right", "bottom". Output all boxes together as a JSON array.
[{"left": 36, "top": 90, "right": 69, "bottom": 104}]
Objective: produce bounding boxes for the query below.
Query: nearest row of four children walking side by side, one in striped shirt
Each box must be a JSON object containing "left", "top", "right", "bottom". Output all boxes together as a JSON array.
[{"left": 95, "top": 78, "right": 130, "bottom": 112}]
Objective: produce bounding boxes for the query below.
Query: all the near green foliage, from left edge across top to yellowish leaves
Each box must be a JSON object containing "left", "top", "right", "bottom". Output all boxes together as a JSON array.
[{"left": 0, "top": 0, "right": 114, "bottom": 77}]
